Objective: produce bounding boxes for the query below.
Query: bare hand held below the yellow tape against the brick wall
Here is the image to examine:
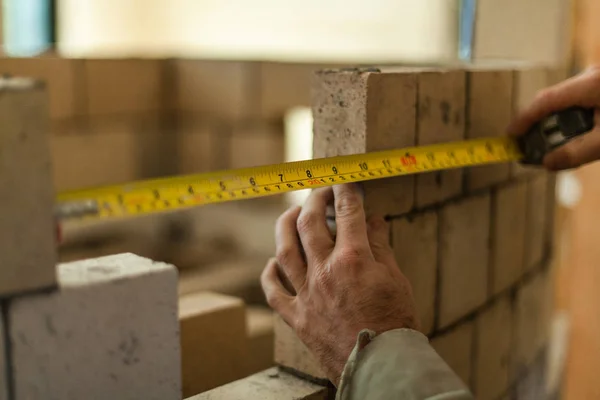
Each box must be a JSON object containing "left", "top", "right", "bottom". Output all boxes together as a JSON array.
[{"left": 261, "top": 184, "right": 419, "bottom": 385}]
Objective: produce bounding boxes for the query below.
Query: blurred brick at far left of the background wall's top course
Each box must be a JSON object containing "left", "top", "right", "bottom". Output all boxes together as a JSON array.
[{"left": 0, "top": 57, "right": 84, "bottom": 120}]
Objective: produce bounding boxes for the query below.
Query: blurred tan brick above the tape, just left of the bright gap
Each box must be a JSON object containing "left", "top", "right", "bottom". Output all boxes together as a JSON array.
[{"left": 229, "top": 125, "right": 285, "bottom": 168}]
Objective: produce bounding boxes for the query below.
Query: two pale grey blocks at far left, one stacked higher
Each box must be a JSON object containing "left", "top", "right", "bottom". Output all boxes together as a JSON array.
[{"left": 0, "top": 79, "right": 181, "bottom": 400}]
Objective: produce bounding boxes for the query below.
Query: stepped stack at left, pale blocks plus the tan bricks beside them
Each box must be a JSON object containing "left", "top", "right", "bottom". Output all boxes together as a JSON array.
[{"left": 0, "top": 78, "right": 312, "bottom": 400}]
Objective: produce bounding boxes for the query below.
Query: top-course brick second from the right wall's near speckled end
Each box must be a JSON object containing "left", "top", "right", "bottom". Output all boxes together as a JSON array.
[{"left": 415, "top": 71, "right": 466, "bottom": 207}]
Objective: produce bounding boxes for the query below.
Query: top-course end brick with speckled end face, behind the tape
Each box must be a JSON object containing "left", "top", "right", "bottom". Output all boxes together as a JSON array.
[{"left": 311, "top": 71, "right": 417, "bottom": 215}]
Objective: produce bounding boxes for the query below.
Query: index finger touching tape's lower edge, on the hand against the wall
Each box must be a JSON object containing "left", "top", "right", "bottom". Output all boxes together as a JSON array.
[{"left": 333, "top": 184, "right": 370, "bottom": 252}]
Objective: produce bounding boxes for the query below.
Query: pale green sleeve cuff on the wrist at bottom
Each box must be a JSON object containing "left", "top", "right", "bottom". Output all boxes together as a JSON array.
[{"left": 336, "top": 329, "right": 474, "bottom": 400}]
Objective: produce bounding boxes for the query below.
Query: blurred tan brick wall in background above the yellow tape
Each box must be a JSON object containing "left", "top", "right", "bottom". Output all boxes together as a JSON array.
[{"left": 0, "top": 55, "right": 340, "bottom": 191}]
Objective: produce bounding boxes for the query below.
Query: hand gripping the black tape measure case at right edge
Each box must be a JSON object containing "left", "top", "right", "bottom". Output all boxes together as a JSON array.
[{"left": 508, "top": 66, "right": 600, "bottom": 171}]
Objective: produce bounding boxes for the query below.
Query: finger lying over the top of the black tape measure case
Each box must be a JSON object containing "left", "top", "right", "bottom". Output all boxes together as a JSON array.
[{"left": 508, "top": 69, "right": 600, "bottom": 136}]
